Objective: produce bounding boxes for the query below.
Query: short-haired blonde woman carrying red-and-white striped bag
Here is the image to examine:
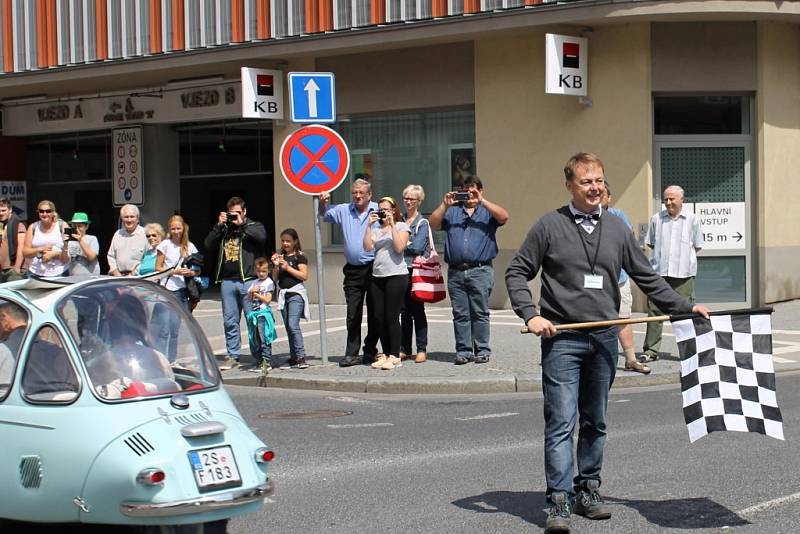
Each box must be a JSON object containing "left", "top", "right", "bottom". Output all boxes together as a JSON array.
[{"left": 400, "top": 185, "right": 431, "bottom": 363}]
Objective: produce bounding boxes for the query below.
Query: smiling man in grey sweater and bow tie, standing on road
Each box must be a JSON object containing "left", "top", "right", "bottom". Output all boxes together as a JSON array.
[{"left": 506, "top": 152, "right": 708, "bottom": 533}]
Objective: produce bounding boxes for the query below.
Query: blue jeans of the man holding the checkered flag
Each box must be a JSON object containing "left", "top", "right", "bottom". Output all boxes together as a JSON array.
[{"left": 542, "top": 327, "right": 617, "bottom": 502}]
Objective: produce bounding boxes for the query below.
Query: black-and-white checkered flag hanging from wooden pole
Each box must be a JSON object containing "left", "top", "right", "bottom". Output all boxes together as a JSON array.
[{"left": 672, "top": 308, "right": 784, "bottom": 442}]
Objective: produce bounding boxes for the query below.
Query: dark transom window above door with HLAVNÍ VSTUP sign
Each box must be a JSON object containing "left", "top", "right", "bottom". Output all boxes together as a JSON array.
[{"left": 653, "top": 95, "right": 750, "bottom": 135}]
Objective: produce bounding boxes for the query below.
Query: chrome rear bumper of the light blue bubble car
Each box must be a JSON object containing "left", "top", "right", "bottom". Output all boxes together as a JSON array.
[{"left": 119, "top": 480, "right": 274, "bottom": 517}]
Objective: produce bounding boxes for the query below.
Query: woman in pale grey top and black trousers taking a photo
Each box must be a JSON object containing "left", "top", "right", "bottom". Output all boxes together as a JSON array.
[{"left": 364, "top": 197, "right": 409, "bottom": 370}]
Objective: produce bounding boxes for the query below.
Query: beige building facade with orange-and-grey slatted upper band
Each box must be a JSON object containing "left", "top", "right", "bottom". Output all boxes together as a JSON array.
[{"left": 0, "top": 0, "right": 800, "bottom": 308}]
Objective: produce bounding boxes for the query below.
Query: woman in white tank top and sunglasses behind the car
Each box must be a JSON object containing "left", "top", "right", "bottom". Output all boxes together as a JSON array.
[{"left": 22, "top": 200, "right": 69, "bottom": 276}]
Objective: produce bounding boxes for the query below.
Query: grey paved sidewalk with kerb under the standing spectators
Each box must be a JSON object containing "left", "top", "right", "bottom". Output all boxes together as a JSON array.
[{"left": 189, "top": 293, "right": 800, "bottom": 394}]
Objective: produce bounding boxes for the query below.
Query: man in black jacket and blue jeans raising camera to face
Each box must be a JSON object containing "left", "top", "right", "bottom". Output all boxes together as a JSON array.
[{"left": 205, "top": 197, "right": 267, "bottom": 370}]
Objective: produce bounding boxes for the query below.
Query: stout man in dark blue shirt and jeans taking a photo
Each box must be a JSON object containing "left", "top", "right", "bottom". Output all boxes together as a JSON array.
[{"left": 429, "top": 176, "right": 508, "bottom": 365}]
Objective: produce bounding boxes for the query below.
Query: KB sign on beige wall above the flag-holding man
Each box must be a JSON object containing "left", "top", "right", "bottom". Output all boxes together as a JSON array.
[{"left": 545, "top": 33, "right": 589, "bottom": 96}]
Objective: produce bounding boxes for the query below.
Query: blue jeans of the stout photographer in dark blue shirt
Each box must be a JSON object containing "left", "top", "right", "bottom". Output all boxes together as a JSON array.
[{"left": 447, "top": 265, "right": 494, "bottom": 359}]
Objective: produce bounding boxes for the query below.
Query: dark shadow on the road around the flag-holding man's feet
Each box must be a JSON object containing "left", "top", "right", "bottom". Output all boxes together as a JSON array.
[{"left": 453, "top": 491, "right": 750, "bottom": 530}]
